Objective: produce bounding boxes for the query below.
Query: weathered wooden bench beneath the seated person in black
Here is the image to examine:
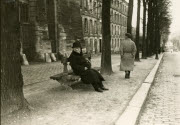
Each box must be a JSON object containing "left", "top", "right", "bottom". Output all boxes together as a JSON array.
[{"left": 50, "top": 54, "right": 100, "bottom": 89}]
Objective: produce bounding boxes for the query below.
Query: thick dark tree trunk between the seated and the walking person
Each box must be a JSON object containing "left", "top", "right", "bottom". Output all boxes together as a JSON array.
[{"left": 101, "top": 0, "right": 112, "bottom": 75}]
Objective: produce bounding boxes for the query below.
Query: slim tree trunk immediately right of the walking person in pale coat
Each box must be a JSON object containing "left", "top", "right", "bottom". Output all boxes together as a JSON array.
[{"left": 135, "top": 0, "right": 141, "bottom": 61}]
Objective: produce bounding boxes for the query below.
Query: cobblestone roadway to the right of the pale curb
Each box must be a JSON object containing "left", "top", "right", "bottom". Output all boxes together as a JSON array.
[{"left": 139, "top": 52, "right": 180, "bottom": 125}]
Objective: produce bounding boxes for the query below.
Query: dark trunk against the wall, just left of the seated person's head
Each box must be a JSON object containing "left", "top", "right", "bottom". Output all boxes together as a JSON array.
[{"left": 47, "top": 0, "right": 59, "bottom": 53}]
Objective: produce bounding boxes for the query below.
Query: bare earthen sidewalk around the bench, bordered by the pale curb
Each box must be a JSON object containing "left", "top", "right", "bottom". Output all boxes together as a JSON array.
[{"left": 2, "top": 55, "right": 157, "bottom": 125}]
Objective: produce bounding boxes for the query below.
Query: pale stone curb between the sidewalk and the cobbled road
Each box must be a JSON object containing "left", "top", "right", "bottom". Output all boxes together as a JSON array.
[{"left": 115, "top": 53, "right": 164, "bottom": 125}]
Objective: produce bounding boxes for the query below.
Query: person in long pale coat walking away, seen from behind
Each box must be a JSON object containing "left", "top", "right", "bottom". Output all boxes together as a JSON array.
[{"left": 120, "top": 33, "right": 137, "bottom": 79}]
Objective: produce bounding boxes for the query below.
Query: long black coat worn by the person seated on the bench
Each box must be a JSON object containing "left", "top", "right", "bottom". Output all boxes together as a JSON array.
[{"left": 68, "top": 51, "right": 104, "bottom": 84}]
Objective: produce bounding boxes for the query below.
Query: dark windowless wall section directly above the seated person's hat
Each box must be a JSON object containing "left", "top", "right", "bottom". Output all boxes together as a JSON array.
[{"left": 58, "top": 0, "right": 84, "bottom": 50}]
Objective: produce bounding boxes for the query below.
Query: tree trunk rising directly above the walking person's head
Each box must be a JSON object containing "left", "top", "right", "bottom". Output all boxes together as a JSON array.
[{"left": 127, "top": 0, "right": 134, "bottom": 34}]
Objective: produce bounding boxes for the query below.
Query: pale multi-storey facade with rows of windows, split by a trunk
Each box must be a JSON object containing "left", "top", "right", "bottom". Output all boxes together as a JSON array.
[{"left": 80, "top": 0, "right": 128, "bottom": 53}]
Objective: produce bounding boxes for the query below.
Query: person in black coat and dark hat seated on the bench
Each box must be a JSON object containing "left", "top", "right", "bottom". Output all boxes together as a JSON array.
[{"left": 68, "top": 41, "right": 108, "bottom": 92}]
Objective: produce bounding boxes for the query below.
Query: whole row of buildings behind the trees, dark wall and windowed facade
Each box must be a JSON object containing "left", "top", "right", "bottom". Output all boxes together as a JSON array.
[{"left": 20, "top": 0, "right": 128, "bottom": 60}]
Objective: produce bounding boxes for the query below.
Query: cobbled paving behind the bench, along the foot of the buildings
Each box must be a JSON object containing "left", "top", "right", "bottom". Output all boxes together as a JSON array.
[{"left": 22, "top": 54, "right": 120, "bottom": 85}]
